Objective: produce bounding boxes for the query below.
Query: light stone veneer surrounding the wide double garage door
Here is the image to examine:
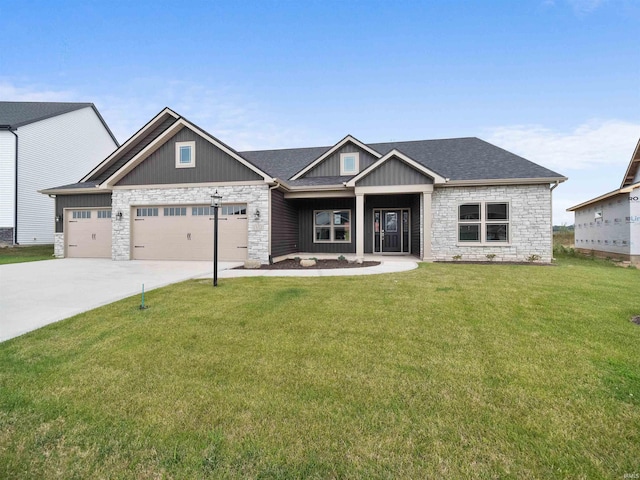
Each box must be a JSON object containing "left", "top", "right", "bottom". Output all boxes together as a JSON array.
[{"left": 111, "top": 184, "right": 269, "bottom": 263}]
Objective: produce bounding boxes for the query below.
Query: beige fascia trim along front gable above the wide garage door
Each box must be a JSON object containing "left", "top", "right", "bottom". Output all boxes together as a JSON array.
[{"left": 100, "top": 118, "right": 272, "bottom": 188}]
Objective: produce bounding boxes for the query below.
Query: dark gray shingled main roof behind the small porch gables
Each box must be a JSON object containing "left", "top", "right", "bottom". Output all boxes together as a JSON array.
[{"left": 240, "top": 137, "right": 563, "bottom": 185}]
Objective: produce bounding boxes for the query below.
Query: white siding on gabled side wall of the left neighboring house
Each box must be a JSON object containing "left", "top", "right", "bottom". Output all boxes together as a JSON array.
[{"left": 17, "top": 107, "right": 117, "bottom": 245}]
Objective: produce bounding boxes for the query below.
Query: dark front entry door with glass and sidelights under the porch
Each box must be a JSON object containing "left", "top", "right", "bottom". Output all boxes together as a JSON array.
[{"left": 373, "top": 209, "right": 409, "bottom": 253}]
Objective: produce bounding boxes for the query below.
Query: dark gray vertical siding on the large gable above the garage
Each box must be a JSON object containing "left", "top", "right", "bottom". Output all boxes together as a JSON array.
[{"left": 117, "top": 127, "right": 262, "bottom": 186}]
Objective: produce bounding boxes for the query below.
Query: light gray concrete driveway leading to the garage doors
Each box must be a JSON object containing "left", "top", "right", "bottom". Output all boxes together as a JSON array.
[{"left": 0, "top": 258, "right": 242, "bottom": 342}]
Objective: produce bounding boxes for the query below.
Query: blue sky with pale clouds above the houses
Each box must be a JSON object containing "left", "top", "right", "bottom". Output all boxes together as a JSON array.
[{"left": 0, "top": 0, "right": 640, "bottom": 224}]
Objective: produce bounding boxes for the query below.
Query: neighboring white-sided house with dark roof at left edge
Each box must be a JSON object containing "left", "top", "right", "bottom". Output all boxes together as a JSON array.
[{"left": 0, "top": 102, "right": 119, "bottom": 245}]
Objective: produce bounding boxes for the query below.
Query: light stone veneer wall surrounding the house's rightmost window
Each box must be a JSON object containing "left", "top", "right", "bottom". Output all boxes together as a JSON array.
[{"left": 431, "top": 184, "right": 553, "bottom": 263}]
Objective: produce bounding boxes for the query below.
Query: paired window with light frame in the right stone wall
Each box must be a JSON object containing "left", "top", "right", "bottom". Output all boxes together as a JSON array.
[{"left": 458, "top": 202, "right": 510, "bottom": 243}]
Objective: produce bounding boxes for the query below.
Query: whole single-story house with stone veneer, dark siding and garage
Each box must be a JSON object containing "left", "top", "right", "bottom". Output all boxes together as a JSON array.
[{"left": 42, "top": 108, "right": 566, "bottom": 263}]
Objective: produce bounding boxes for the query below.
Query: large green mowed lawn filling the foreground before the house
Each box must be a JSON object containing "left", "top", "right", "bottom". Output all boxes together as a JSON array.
[{"left": 0, "top": 258, "right": 640, "bottom": 479}]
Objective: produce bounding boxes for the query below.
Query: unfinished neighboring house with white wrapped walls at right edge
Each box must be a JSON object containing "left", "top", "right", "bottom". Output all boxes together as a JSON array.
[{"left": 567, "top": 137, "right": 640, "bottom": 264}]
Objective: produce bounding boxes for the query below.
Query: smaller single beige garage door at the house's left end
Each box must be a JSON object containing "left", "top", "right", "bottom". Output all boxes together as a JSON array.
[{"left": 65, "top": 209, "right": 111, "bottom": 258}]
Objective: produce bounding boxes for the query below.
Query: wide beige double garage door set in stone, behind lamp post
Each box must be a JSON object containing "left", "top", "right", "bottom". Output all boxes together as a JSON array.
[{"left": 131, "top": 205, "right": 248, "bottom": 261}]
